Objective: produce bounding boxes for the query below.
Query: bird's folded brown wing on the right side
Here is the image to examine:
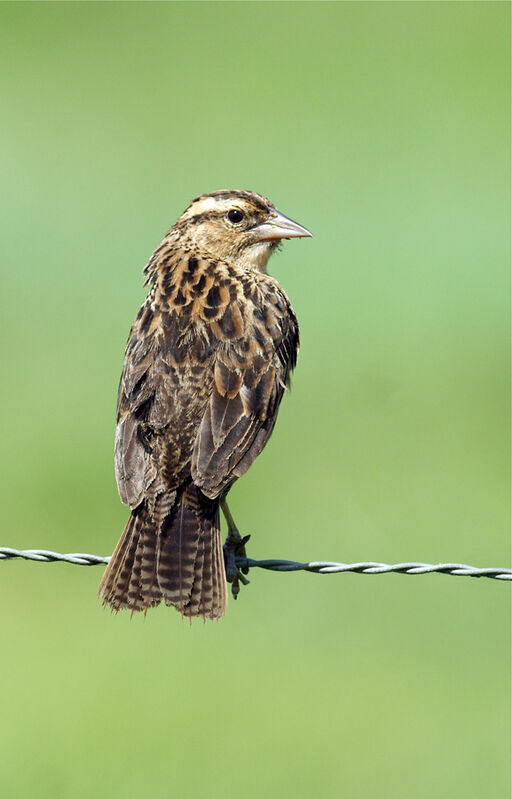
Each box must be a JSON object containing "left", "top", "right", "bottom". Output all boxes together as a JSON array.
[{"left": 192, "top": 304, "right": 299, "bottom": 498}]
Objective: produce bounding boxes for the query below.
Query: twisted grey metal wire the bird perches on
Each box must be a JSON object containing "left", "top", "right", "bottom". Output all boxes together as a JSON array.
[{"left": 0, "top": 547, "right": 512, "bottom": 580}]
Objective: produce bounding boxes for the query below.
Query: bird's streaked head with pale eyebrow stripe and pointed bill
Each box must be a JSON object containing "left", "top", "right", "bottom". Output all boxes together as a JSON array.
[{"left": 170, "top": 190, "right": 311, "bottom": 271}]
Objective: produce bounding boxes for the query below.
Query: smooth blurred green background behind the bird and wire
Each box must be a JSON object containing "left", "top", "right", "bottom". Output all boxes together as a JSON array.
[{"left": 0, "top": 2, "right": 510, "bottom": 799}]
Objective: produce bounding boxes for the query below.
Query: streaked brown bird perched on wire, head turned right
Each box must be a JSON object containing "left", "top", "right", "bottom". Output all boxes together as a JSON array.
[{"left": 98, "top": 190, "right": 312, "bottom": 620}]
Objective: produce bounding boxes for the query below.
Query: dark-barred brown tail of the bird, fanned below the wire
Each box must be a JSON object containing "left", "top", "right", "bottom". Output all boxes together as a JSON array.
[{"left": 99, "top": 484, "right": 227, "bottom": 619}]
